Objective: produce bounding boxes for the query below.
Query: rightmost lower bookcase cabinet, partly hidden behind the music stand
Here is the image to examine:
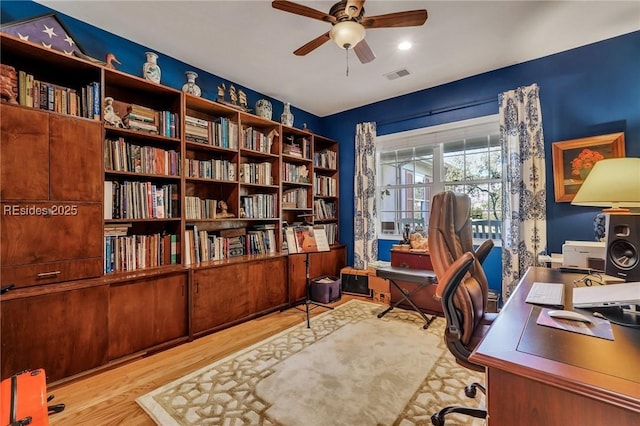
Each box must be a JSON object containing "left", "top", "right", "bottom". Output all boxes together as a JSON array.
[{"left": 289, "top": 245, "right": 347, "bottom": 304}]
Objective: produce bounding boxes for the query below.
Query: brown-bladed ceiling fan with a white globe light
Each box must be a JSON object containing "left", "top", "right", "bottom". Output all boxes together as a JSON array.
[{"left": 271, "top": 0, "right": 427, "bottom": 64}]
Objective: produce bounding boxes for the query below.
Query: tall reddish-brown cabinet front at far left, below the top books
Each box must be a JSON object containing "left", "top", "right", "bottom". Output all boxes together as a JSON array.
[{"left": 0, "top": 104, "right": 102, "bottom": 287}]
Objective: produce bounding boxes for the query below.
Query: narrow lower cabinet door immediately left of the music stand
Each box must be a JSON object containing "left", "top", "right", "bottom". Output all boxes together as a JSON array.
[{"left": 249, "top": 257, "right": 288, "bottom": 313}]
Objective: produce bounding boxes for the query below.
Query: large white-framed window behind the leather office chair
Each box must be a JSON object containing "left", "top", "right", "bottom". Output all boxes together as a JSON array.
[{"left": 376, "top": 115, "right": 502, "bottom": 239}]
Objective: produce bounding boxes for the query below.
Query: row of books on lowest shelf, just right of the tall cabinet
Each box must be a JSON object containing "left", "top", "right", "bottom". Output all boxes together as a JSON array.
[{"left": 104, "top": 228, "right": 178, "bottom": 274}]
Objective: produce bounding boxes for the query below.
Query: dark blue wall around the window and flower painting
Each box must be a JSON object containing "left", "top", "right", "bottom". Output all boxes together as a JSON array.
[{"left": 322, "top": 31, "right": 640, "bottom": 289}]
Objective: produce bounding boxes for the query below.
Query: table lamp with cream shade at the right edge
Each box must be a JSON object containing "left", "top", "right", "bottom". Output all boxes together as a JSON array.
[{"left": 571, "top": 158, "right": 640, "bottom": 214}]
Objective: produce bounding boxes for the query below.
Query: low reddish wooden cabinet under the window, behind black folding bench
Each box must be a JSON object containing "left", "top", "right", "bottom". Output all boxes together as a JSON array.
[{"left": 390, "top": 250, "right": 442, "bottom": 315}]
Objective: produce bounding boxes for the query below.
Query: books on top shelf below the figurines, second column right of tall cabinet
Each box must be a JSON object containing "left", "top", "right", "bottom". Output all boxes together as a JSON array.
[{"left": 184, "top": 115, "right": 238, "bottom": 150}]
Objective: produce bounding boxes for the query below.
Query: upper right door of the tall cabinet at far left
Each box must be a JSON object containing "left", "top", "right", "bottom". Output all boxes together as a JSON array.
[{"left": 49, "top": 111, "right": 104, "bottom": 203}]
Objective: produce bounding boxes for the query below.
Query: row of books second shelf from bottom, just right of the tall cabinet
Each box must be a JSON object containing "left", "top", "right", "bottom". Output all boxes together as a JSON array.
[{"left": 104, "top": 181, "right": 180, "bottom": 220}]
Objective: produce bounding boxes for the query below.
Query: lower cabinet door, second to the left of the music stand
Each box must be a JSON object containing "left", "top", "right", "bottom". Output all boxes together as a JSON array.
[{"left": 191, "top": 263, "right": 251, "bottom": 333}]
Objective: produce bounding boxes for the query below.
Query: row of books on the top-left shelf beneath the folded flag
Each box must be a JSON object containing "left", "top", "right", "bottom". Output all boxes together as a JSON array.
[{"left": 18, "top": 71, "right": 101, "bottom": 120}]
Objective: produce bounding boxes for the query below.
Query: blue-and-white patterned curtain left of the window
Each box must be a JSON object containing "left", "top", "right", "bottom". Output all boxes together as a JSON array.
[{"left": 353, "top": 122, "right": 378, "bottom": 269}]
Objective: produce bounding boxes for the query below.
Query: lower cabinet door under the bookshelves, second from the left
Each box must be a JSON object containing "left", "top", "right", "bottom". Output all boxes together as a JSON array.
[{"left": 108, "top": 272, "right": 188, "bottom": 360}]
